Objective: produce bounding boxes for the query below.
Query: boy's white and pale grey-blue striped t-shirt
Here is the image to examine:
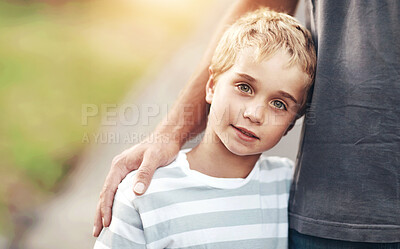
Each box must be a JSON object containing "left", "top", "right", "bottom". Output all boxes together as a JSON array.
[{"left": 94, "top": 150, "right": 293, "bottom": 249}]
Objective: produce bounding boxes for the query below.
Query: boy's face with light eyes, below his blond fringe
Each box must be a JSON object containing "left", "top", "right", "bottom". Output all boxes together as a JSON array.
[{"left": 206, "top": 48, "right": 309, "bottom": 156}]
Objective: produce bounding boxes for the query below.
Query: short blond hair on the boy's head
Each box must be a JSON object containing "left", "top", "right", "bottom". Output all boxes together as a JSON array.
[{"left": 210, "top": 8, "right": 316, "bottom": 111}]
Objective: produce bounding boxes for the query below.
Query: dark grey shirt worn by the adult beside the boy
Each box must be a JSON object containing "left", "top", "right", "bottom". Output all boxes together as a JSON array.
[{"left": 289, "top": 0, "right": 400, "bottom": 242}]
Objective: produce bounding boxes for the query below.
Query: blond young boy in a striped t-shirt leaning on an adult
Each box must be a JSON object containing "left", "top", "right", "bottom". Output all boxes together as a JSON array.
[{"left": 95, "top": 9, "right": 316, "bottom": 249}]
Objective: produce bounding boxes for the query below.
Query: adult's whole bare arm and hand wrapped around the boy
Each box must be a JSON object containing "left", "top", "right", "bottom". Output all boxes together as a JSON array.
[{"left": 93, "top": 0, "right": 298, "bottom": 237}]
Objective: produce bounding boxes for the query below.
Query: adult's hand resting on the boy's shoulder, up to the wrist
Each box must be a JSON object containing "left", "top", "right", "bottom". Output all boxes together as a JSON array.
[{"left": 93, "top": 136, "right": 180, "bottom": 237}]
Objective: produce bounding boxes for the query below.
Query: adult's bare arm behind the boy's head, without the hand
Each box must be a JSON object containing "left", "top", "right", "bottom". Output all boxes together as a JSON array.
[{"left": 155, "top": 0, "right": 298, "bottom": 147}]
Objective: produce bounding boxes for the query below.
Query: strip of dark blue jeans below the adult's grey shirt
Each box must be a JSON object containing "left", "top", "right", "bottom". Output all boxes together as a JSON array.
[{"left": 289, "top": 229, "right": 400, "bottom": 249}]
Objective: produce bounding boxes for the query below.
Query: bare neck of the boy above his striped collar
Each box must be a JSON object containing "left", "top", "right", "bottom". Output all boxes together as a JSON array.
[{"left": 187, "top": 129, "right": 261, "bottom": 178}]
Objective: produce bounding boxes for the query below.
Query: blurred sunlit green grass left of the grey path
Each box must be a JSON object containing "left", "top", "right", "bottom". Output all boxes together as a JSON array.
[{"left": 0, "top": 0, "right": 210, "bottom": 245}]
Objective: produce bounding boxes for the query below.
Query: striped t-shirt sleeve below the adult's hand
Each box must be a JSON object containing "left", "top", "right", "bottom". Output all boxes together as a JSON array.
[{"left": 94, "top": 172, "right": 146, "bottom": 249}]
